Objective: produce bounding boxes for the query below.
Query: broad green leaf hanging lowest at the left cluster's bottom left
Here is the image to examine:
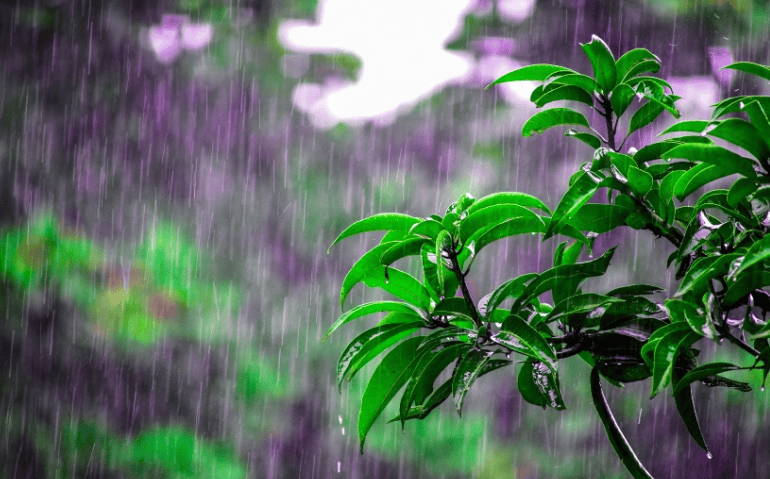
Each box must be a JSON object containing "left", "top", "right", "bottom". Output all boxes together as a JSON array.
[{"left": 358, "top": 336, "right": 424, "bottom": 454}]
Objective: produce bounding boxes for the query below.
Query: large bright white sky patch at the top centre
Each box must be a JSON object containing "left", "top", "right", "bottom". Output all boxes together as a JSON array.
[{"left": 278, "top": 0, "right": 474, "bottom": 128}]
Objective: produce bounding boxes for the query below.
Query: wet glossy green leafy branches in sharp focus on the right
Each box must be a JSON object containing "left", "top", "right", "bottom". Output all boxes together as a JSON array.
[{"left": 324, "top": 36, "right": 770, "bottom": 478}]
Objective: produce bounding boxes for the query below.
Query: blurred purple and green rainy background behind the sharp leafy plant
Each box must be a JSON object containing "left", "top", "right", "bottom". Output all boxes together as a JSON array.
[{"left": 0, "top": 0, "right": 770, "bottom": 478}]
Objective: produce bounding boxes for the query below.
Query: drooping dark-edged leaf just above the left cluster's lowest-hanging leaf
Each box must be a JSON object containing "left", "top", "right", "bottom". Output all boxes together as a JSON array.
[{"left": 337, "top": 322, "right": 424, "bottom": 393}]
